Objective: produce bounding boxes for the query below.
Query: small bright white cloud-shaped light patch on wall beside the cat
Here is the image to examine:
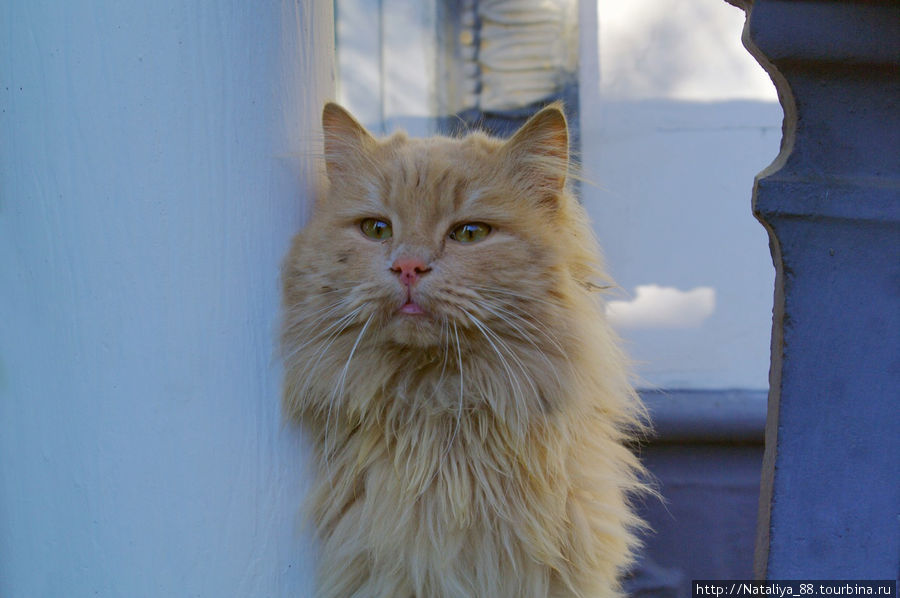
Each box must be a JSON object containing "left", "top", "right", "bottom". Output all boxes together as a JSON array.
[{"left": 606, "top": 284, "right": 716, "bottom": 328}]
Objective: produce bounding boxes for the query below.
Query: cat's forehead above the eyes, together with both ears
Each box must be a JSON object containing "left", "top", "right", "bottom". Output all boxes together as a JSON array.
[{"left": 323, "top": 104, "right": 568, "bottom": 223}]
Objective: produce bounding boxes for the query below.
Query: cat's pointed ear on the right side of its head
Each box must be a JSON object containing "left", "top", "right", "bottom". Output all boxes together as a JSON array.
[{"left": 503, "top": 102, "right": 569, "bottom": 195}]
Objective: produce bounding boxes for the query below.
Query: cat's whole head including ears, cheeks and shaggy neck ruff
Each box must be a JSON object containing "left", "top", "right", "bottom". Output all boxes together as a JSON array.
[{"left": 282, "top": 104, "right": 612, "bottom": 421}]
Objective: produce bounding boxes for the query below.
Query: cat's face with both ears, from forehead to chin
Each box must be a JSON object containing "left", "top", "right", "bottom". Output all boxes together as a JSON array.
[{"left": 286, "top": 104, "right": 573, "bottom": 348}]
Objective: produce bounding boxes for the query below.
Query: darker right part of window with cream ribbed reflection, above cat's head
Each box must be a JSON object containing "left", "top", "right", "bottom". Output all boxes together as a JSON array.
[{"left": 436, "top": 0, "right": 578, "bottom": 135}]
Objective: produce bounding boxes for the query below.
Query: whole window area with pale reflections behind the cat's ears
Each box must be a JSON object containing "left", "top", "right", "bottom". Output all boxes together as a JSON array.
[{"left": 336, "top": 0, "right": 579, "bottom": 135}]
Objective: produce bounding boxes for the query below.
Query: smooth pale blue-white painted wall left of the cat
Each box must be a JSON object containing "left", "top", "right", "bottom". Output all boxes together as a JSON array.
[{"left": 0, "top": 0, "right": 333, "bottom": 598}]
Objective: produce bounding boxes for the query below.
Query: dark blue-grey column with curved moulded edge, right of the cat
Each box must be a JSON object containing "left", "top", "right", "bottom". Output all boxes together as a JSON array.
[{"left": 734, "top": 0, "right": 900, "bottom": 579}]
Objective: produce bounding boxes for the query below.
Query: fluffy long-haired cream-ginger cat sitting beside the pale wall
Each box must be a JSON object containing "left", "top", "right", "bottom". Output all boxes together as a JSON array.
[{"left": 282, "top": 103, "right": 645, "bottom": 598}]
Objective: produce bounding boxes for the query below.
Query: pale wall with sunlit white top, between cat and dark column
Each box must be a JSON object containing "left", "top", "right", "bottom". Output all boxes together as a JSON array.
[{"left": 581, "top": 0, "right": 782, "bottom": 389}]
